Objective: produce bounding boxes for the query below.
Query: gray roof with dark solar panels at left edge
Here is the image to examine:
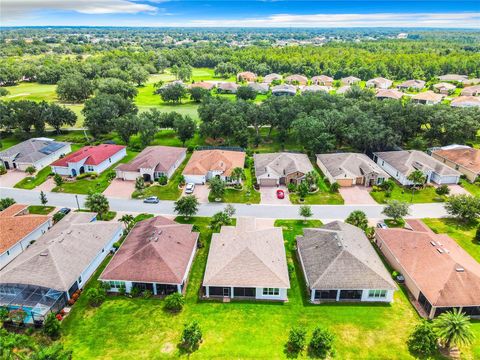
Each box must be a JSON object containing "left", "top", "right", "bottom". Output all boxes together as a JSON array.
[{"left": 0, "top": 138, "right": 68, "bottom": 163}]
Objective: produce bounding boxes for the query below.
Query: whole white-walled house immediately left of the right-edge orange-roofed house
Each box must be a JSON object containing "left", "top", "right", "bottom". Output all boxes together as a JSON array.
[{"left": 373, "top": 150, "right": 461, "bottom": 185}]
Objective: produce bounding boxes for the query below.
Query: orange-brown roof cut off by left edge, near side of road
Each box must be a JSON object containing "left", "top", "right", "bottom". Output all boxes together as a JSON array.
[{"left": 0, "top": 204, "right": 50, "bottom": 254}]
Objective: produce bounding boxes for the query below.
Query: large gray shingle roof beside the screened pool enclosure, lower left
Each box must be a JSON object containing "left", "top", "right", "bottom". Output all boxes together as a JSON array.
[{"left": 0, "top": 212, "right": 122, "bottom": 291}]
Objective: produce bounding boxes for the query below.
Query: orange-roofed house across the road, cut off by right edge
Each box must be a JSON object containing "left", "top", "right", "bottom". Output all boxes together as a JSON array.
[{"left": 432, "top": 145, "right": 480, "bottom": 182}]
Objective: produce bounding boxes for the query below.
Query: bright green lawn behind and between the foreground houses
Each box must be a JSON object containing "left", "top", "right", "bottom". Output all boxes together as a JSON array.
[{"left": 57, "top": 218, "right": 472, "bottom": 359}]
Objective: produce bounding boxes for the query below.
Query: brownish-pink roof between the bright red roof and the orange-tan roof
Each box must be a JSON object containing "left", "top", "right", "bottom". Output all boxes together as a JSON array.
[{"left": 117, "top": 146, "right": 187, "bottom": 172}]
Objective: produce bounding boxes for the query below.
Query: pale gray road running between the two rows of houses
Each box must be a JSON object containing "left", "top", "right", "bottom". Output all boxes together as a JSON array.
[{"left": 0, "top": 187, "right": 447, "bottom": 220}]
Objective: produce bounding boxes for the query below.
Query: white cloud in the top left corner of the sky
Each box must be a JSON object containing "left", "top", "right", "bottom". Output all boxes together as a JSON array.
[{"left": 1, "top": 0, "right": 159, "bottom": 19}]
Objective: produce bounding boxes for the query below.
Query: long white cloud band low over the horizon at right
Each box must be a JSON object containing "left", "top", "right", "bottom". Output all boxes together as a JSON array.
[{"left": 189, "top": 12, "right": 480, "bottom": 28}]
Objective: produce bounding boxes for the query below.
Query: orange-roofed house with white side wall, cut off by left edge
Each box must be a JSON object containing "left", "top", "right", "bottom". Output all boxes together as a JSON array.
[{"left": 0, "top": 204, "right": 52, "bottom": 269}]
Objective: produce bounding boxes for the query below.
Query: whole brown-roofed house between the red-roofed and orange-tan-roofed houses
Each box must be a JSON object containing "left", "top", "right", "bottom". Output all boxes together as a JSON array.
[{"left": 115, "top": 146, "right": 187, "bottom": 181}]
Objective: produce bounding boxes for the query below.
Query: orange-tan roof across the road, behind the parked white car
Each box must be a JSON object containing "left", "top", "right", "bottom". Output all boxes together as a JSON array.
[{"left": 183, "top": 150, "right": 245, "bottom": 176}]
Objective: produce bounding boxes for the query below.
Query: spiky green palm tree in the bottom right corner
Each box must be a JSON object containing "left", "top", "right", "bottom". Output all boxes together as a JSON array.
[{"left": 433, "top": 309, "right": 474, "bottom": 349}]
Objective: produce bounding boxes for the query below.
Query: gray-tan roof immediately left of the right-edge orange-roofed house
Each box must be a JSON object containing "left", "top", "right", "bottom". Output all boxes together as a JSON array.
[{"left": 375, "top": 150, "right": 461, "bottom": 176}]
